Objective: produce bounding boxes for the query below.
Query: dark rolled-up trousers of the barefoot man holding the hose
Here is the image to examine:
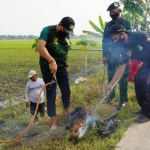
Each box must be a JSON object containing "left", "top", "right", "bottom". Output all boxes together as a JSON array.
[{"left": 41, "top": 67, "right": 71, "bottom": 117}]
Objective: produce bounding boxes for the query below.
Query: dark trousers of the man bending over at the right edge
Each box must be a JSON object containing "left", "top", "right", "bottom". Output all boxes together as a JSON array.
[{"left": 134, "top": 63, "right": 150, "bottom": 116}]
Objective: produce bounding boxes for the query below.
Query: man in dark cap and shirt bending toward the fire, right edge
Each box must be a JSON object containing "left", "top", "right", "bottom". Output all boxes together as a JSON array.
[{"left": 107, "top": 25, "right": 150, "bottom": 123}]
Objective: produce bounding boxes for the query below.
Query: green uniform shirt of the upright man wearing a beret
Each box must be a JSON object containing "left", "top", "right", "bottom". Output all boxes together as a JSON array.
[{"left": 102, "top": 18, "right": 131, "bottom": 57}]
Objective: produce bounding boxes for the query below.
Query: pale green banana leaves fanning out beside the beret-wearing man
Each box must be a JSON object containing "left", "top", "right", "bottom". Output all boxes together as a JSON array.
[{"left": 82, "top": 16, "right": 107, "bottom": 37}]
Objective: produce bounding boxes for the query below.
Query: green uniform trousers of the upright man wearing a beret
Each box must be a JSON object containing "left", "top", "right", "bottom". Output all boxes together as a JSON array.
[{"left": 108, "top": 50, "right": 129, "bottom": 104}]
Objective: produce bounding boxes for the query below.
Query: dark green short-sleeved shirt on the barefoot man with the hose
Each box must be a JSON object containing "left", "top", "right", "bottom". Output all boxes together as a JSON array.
[{"left": 39, "top": 25, "right": 69, "bottom": 71}]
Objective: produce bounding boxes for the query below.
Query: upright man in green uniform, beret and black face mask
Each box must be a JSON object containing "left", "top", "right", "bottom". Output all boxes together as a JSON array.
[{"left": 102, "top": 2, "right": 131, "bottom": 110}]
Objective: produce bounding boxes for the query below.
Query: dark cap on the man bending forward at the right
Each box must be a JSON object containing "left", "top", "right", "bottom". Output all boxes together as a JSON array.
[{"left": 109, "top": 24, "right": 129, "bottom": 36}]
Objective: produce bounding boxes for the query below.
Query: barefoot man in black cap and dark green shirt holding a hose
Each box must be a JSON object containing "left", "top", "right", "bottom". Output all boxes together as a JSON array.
[{"left": 37, "top": 17, "right": 75, "bottom": 130}]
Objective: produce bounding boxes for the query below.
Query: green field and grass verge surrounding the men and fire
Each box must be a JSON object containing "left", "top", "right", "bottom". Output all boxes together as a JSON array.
[{"left": 0, "top": 40, "right": 139, "bottom": 150}]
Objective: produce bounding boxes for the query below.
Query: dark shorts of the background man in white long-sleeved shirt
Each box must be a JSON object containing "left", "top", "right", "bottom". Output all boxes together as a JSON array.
[{"left": 30, "top": 102, "right": 45, "bottom": 117}]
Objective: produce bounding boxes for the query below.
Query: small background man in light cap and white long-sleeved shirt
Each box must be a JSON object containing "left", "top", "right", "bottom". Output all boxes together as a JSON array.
[{"left": 25, "top": 70, "right": 45, "bottom": 120}]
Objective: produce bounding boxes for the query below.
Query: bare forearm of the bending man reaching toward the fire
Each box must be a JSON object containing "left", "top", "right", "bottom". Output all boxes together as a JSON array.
[{"left": 107, "top": 63, "right": 127, "bottom": 91}]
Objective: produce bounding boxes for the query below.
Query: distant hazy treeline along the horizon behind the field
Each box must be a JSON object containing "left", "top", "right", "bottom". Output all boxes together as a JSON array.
[{"left": 0, "top": 35, "right": 99, "bottom": 40}]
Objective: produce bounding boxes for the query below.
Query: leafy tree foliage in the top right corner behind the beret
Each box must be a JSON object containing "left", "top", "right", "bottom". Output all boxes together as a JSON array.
[{"left": 120, "top": 0, "right": 150, "bottom": 31}]
